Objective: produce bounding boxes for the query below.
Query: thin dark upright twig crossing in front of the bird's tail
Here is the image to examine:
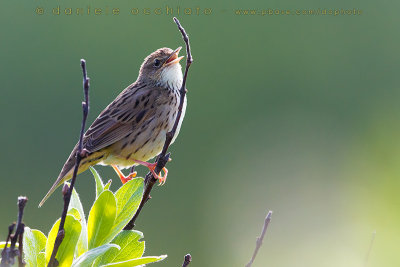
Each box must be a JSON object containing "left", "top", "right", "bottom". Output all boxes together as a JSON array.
[{"left": 47, "top": 59, "right": 89, "bottom": 267}]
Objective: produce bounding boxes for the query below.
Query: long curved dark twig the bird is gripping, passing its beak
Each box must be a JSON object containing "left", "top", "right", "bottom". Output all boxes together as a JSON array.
[{"left": 124, "top": 17, "right": 193, "bottom": 230}]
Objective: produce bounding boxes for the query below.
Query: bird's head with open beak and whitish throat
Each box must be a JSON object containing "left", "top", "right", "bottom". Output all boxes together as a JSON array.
[{"left": 139, "top": 47, "right": 183, "bottom": 89}]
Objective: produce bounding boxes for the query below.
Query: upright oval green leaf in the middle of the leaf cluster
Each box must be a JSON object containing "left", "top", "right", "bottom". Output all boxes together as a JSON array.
[{"left": 88, "top": 190, "right": 117, "bottom": 249}]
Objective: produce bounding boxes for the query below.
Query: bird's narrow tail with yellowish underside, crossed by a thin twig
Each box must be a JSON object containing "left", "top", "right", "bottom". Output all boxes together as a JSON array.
[{"left": 39, "top": 147, "right": 103, "bottom": 207}]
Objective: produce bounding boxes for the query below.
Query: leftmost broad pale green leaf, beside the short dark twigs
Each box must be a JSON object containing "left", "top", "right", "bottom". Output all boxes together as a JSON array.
[{"left": 23, "top": 227, "right": 47, "bottom": 267}]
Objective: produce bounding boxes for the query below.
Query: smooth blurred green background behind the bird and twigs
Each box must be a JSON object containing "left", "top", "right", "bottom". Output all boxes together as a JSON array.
[{"left": 0, "top": 0, "right": 400, "bottom": 267}]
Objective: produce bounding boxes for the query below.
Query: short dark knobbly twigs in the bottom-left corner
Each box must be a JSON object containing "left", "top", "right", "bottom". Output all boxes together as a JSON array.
[{"left": 0, "top": 197, "right": 28, "bottom": 267}]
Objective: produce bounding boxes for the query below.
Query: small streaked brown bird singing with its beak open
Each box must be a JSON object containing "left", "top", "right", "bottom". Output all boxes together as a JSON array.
[{"left": 39, "top": 47, "right": 187, "bottom": 207}]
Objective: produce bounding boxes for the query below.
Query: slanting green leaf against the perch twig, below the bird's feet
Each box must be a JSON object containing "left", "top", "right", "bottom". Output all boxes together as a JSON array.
[{"left": 107, "top": 178, "right": 144, "bottom": 242}]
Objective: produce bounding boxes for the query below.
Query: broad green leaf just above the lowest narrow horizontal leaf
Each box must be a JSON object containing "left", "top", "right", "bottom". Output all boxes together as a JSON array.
[{"left": 95, "top": 230, "right": 144, "bottom": 266}]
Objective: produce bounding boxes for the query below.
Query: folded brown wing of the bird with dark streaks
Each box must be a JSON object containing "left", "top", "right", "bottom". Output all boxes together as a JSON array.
[{"left": 83, "top": 84, "right": 158, "bottom": 153}]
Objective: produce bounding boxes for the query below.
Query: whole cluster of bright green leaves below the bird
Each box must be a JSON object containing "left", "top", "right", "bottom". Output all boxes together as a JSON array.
[{"left": 0, "top": 171, "right": 166, "bottom": 267}]
